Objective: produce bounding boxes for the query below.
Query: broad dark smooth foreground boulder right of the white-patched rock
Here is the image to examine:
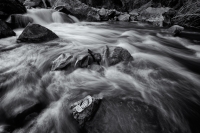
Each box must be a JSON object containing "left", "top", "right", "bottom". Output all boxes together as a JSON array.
[{"left": 84, "top": 98, "right": 162, "bottom": 133}]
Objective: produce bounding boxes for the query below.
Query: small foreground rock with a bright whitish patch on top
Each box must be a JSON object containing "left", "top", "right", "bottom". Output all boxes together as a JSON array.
[{"left": 71, "top": 96, "right": 101, "bottom": 128}]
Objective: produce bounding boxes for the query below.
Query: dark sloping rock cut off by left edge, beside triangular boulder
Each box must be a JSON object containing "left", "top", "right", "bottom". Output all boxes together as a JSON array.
[{"left": 0, "top": 20, "right": 16, "bottom": 38}]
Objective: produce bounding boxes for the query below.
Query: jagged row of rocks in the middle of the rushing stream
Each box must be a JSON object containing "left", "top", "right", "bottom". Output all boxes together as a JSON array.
[{"left": 51, "top": 46, "right": 133, "bottom": 73}]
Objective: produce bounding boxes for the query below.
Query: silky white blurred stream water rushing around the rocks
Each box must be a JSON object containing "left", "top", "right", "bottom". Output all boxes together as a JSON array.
[{"left": 0, "top": 9, "right": 200, "bottom": 133}]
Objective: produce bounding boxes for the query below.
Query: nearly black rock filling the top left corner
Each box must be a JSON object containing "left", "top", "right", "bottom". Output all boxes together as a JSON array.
[{"left": 0, "top": 0, "right": 26, "bottom": 19}]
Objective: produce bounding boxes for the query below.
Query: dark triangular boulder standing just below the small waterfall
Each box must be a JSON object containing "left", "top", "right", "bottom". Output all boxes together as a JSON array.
[{"left": 17, "top": 24, "right": 58, "bottom": 43}]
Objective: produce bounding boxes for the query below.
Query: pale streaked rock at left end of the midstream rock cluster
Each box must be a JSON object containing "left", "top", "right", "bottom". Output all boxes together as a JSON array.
[{"left": 51, "top": 54, "right": 73, "bottom": 71}]
